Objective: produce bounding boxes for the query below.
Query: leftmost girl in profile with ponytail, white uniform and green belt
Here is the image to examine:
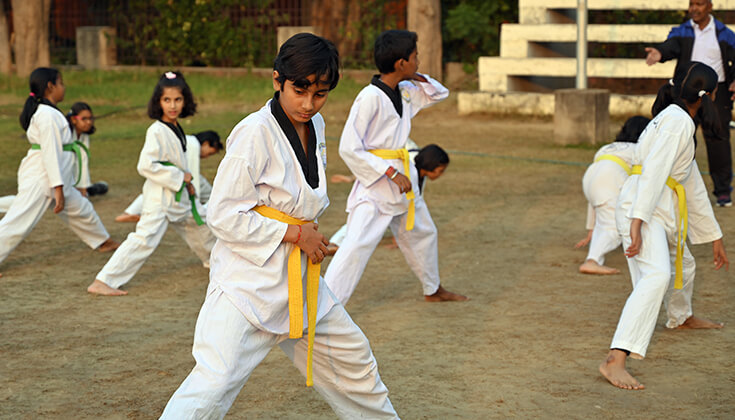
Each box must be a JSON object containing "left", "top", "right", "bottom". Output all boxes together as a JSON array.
[{"left": 0, "top": 67, "right": 118, "bottom": 278}]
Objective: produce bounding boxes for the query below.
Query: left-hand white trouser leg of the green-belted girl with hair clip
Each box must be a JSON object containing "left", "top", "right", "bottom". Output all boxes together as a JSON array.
[{"left": 95, "top": 212, "right": 168, "bottom": 289}]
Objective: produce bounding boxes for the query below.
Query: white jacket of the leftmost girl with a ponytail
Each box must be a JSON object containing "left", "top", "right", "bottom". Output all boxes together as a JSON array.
[{"left": 18, "top": 104, "right": 77, "bottom": 193}]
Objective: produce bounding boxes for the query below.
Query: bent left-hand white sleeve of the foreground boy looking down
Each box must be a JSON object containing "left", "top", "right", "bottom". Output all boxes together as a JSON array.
[{"left": 207, "top": 124, "right": 288, "bottom": 266}]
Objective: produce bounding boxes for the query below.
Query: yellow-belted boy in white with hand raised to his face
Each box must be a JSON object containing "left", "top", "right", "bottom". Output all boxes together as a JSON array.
[{"left": 324, "top": 30, "right": 467, "bottom": 305}]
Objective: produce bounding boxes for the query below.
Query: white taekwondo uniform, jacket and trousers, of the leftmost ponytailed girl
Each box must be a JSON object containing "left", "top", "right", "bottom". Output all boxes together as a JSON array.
[{"left": 0, "top": 104, "right": 110, "bottom": 262}]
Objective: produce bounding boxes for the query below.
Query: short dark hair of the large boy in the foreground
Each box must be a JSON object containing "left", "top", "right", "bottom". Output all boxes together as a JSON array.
[{"left": 273, "top": 33, "right": 339, "bottom": 90}]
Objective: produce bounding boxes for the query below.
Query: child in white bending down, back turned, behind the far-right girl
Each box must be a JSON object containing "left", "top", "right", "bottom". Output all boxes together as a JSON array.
[{"left": 575, "top": 115, "right": 651, "bottom": 274}]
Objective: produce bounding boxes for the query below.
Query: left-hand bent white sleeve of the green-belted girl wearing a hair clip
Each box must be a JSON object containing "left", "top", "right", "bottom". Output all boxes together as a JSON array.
[{"left": 138, "top": 127, "right": 184, "bottom": 191}]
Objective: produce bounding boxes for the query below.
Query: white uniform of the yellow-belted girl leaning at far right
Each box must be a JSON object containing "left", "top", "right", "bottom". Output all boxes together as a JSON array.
[{"left": 610, "top": 104, "right": 722, "bottom": 358}]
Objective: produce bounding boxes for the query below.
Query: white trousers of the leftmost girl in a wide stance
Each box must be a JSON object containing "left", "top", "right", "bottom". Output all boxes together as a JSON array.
[{"left": 0, "top": 183, "right": 110, "bottom": 262}]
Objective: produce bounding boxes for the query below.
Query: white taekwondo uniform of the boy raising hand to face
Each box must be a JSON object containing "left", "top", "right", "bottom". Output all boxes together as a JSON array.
[{"left": 324, "top": 75, "right": 449, "bottom": 305}]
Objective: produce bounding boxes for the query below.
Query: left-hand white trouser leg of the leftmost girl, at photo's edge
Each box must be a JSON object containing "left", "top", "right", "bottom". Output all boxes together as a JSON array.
[{"left": 0, "top": 185, "right": 53, "bottom": 262}]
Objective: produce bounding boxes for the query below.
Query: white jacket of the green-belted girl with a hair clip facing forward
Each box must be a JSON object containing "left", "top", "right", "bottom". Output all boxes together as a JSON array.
[{"left": 138, "top": 121, "right": 196, "bottom": 222}]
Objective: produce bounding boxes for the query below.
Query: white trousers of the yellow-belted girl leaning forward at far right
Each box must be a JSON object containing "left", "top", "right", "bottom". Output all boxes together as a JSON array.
[{"left": 610, "top": 217, "right": 696, "bottom": 358}]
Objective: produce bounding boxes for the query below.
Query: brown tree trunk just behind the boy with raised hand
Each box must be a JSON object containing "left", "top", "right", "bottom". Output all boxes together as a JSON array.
[{"left": 407, "top": 0, "right": 442, "bottom": 80}]
